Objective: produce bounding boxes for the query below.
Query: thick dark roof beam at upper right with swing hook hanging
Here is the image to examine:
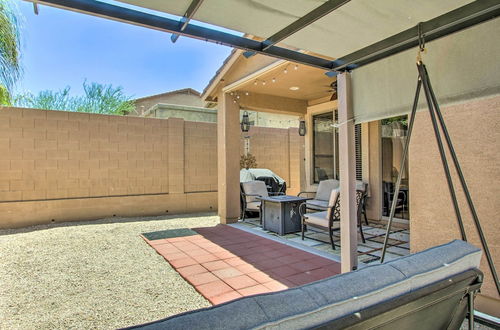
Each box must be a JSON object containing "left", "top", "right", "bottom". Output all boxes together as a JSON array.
[{"left": 332, "top": 0, "right": 500, "bottom": 71}]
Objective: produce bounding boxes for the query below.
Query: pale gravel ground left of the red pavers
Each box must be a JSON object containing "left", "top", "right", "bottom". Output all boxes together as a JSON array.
[{"left": 0, "top": 214, "right": 218, "bottom": 329}]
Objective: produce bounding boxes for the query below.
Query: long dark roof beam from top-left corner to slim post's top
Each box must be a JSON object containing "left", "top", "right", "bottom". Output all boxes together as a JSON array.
[{"left": 31, "top": 0, "right": 332, "bottom": 70}]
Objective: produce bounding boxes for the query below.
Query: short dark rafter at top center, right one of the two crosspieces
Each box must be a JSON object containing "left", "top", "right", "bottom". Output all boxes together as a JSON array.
[{"left": 262, "top": 0, "right": 350, "bottom": 50}]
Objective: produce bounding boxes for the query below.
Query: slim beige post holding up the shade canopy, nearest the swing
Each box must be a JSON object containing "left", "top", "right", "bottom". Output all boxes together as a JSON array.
[{"left": 337, "top": 72, "right": 358, "bottom": 273}]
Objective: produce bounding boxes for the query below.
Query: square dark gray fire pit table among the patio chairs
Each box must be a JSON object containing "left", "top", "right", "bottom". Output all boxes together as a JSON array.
[{"left": 258, "top": 195, "right": 311, "bottom": 236}]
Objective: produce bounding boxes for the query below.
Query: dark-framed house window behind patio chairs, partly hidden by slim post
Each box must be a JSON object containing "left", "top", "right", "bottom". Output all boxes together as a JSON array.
[{"left": 312, "top": 110, "right": 363, "bottom": 183}]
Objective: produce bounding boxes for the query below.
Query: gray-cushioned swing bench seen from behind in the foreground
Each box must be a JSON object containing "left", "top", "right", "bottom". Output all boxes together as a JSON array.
[{"left": 127, "top": 240, "right": 483, "bottom": 330}]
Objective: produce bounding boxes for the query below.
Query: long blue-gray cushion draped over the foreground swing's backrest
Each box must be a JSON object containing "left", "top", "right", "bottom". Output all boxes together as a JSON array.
[{"left": 128, "top": 240, "right": 481, "bottom": 330}]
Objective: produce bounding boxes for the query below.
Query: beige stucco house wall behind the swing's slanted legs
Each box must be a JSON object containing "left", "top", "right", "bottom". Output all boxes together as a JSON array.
[{"left": 409, "top": 96, "right": 500, "bottom": 317}]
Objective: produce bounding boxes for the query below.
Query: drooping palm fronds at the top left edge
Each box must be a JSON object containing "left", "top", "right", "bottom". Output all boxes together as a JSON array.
[{"left": 0, "top": 0, "right": 21, "bottom": 104}]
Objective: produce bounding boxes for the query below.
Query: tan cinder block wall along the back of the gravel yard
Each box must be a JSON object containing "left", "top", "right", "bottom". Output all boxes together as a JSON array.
[{"left": 0, "top": 107, "right": 300, "bottom": 228}]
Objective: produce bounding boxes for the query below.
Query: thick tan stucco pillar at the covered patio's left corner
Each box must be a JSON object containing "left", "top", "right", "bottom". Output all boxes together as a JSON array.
[{"left": 217, "top": 92, "right": 240, "bottom": 224}]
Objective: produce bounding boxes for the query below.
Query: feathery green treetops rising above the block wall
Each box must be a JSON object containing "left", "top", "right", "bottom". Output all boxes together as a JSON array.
[{"left": 14, "top": 81, "right": 134, "bottom": 115}]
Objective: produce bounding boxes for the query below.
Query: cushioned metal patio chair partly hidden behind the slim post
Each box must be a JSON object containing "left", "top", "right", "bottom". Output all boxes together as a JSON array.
[{"left": 299, "top": 186, "right": 366, "bottom": 250}]
